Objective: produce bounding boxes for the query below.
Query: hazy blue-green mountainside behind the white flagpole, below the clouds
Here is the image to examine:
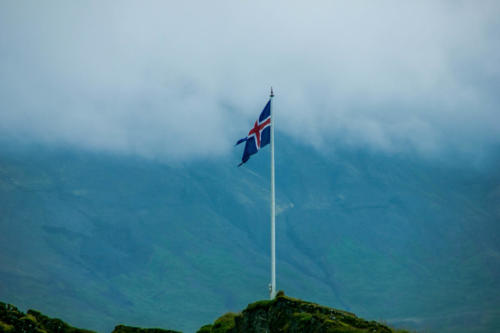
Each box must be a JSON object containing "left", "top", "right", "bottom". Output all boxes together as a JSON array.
[{"left": 0, "top": 136, "right": 500, "bottom": 332}]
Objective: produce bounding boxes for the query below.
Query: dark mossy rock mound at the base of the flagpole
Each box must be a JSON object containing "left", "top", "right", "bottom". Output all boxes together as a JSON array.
[{"left": 198, "top": 293, "right": 404, "bottom": 333}]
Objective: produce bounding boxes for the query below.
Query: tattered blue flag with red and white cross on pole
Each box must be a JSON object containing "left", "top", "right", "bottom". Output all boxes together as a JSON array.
[{"left": 236, "top": 100, "right": 271, "bottom": 166}]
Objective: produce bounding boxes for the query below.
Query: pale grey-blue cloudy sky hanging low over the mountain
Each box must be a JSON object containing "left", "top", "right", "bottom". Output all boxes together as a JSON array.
[{"left": 0, "top": 0, "right": 500, "bottom": 160}]
